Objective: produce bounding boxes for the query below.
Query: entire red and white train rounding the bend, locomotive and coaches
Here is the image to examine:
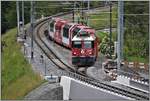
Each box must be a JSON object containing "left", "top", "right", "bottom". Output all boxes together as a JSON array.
[{"left": 48, "top": 17, "right": 98, "bottom": 66}]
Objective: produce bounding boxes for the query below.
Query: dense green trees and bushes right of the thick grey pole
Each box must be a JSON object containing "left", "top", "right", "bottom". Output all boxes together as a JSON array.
[{"left": 124, "top": 1, "right": 149, "bottom": 63}]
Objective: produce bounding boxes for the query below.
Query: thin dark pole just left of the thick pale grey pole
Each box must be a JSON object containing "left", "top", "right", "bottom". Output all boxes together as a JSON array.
[{"left": 109, "top": 1, "right": 112, "bottom": 57}]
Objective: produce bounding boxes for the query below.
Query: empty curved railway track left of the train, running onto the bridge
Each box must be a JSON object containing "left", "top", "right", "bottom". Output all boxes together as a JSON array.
[{"left": 27, "top": 13, "right": 149, "bottom": 100}]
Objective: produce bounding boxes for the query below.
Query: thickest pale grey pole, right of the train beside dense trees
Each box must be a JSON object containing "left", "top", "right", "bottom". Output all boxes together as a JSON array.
[{"left": 117, "top": 0, "right": 123, "bottom": 71}]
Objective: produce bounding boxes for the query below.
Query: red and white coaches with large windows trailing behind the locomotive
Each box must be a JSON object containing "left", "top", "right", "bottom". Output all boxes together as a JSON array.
[{"left": 49, "top": 18, "right": 78, "bottom": 48}]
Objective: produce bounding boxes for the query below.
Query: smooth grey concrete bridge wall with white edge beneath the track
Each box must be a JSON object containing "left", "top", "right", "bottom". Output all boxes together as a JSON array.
[{"left": 60, "top": 76, "right": 131, "bottom": 101}]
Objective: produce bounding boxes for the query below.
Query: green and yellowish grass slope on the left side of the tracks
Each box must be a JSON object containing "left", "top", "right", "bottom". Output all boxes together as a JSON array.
[{"left": 1, "top": 28, "right": 44, "bottom": 100}]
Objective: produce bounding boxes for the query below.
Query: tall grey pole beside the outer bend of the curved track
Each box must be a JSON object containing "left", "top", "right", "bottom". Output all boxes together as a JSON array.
[{"left": 30, "top": 1, "right": 34, "bottom": 59}]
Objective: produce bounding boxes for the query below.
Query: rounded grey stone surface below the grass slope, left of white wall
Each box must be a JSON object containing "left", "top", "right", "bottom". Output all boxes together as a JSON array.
[{"left": 24, "top": 82, "right": 63, "bottom": 100}]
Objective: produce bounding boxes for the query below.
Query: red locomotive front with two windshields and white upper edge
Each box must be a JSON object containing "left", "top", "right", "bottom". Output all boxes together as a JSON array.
[{"left": 72, "top": 29, "right": 97, "bottom": 66}]
